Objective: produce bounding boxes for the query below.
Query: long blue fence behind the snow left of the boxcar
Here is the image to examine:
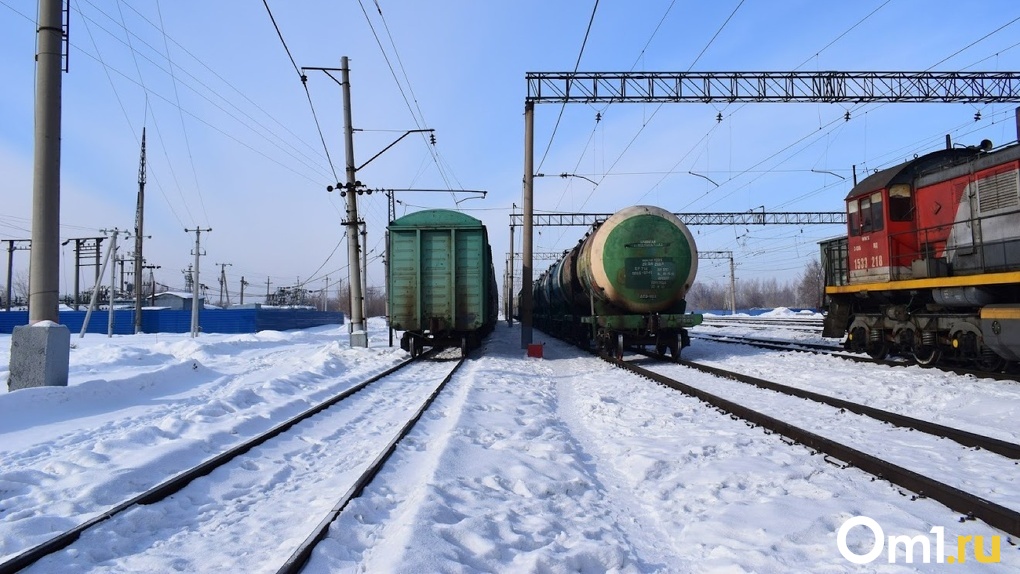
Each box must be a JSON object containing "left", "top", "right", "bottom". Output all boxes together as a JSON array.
[{"left": 0, "top": 306, "right": 344, "bottom": 334}]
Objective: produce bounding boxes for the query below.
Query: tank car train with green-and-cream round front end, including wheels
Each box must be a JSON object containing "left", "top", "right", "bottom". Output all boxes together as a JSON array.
[{"left": 532, "top": 206, "right": 702, "bottom": 360}]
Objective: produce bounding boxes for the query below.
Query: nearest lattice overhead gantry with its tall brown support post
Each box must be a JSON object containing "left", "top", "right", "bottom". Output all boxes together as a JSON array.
[{"left": 520, "top": 71, "right": 1020, "bottom": 348}]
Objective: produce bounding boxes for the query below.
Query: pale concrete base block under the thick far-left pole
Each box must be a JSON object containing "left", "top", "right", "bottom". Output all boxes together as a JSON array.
[{"left": 7, "top": 321, "right": 70, "bottom": 390}]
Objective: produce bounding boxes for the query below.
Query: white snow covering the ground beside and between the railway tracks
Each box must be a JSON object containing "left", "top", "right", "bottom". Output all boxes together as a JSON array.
[{"left": 0, "top": 314, "right": 1020, "bottom": 572}]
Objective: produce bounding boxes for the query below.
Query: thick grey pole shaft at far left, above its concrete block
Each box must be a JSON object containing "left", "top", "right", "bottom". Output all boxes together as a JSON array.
[{"left": 29, "top": 0, "right": 63, "bottom": 325}]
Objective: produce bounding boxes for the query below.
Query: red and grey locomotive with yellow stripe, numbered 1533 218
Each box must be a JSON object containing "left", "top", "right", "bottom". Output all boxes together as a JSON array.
[{"left": 821, "top": 127, "right": 1020, "bottom": 370}]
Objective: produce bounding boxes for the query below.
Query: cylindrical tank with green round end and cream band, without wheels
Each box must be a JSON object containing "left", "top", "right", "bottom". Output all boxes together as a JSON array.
[{"left": 577, "top": 205, "right": 698, "bottom": 313}]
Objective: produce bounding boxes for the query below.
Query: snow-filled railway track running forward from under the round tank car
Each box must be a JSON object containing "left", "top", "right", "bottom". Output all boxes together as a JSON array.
[{"left": 611, "top": 352, "right": 1020, "bottom": 536}]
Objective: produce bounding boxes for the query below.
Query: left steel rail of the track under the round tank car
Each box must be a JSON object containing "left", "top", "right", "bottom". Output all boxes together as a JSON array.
[{"left": 610, "top": 361, "right": 1020, "bottom": 536}]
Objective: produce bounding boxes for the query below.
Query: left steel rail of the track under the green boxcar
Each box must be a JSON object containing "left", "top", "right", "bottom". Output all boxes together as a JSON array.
[{"left": 0, "top": 355, "right": 425, "bottom": 574}]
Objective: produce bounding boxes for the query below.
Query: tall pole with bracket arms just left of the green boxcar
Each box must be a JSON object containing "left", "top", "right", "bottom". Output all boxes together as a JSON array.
[{"left": 340, "top": 56, "right": 368, "bottom": 347}]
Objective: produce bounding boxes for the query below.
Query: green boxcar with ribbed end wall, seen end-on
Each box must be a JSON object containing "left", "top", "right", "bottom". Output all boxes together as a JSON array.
[{"left": 387, "top": 209, "right": 499, "bottom": 356}]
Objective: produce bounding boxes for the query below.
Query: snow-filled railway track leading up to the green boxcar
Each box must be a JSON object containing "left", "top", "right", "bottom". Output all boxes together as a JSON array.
[{"left": 0, "top": 354, "right": 463, "bottom": 574}]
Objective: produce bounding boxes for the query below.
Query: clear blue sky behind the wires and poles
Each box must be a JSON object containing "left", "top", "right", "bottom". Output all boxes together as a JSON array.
[{"left": 0, "top": 0, "right": 1020, "bottom": 305}]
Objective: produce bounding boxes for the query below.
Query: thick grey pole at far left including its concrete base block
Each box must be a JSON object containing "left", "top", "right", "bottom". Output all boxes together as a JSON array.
[{"left": 7, "top": 0, "right": 70, "bottom": 390}]
